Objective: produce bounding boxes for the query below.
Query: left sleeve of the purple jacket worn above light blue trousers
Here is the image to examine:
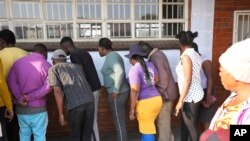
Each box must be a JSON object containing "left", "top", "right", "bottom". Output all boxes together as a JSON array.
[{"left": 8, "top": 64, "right": 23, "bottom": 102}]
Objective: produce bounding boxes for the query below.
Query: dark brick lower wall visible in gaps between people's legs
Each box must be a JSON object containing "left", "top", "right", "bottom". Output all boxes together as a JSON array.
[{"left": 47, "top": 87, "right": 179, "bottom": 136}]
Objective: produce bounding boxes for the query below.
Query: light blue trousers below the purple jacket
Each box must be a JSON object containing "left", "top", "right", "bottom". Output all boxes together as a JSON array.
[{"left": 17, "top": 112, "right": 48, "bottom": 141}]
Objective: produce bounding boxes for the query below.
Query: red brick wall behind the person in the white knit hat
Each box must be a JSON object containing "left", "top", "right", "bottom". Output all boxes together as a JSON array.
[{"left": 213, "top": 0, "right": 250, "bottom": 103}]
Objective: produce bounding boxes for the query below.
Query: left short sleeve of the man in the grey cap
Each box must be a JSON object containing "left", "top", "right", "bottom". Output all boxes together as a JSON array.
[{"left": 48, "top": 67, "right": 62, "bottom": 87}]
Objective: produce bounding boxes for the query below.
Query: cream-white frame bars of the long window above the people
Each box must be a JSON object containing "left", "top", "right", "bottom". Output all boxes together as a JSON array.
[{"left": 0, "top": 0, "right": 189, "bottom": 42}]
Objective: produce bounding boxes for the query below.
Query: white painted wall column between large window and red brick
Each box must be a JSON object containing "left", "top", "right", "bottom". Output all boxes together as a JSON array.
[{"left": 191, "top": 0, "right": 215, "bottom": 59}]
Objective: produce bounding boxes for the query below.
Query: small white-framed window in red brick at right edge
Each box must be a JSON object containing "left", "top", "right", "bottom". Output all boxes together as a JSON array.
[{"left": 233, "top": 11, "right": 250, "bottom": 43}]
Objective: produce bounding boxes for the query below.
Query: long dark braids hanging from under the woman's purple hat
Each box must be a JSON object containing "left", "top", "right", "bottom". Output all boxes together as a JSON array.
[{"left": 131, "top": 55, "right": 152, "bottom": 85}]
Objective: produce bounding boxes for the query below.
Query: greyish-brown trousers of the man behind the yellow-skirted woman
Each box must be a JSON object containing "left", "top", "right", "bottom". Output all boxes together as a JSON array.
[{"left": 157, "top": 101, "right": 174, "bottom": 141}]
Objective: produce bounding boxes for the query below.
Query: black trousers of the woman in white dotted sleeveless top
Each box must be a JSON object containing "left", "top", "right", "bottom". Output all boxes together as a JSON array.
[{"left": 181, "top": 102, "right": 201, "bottom": 141}]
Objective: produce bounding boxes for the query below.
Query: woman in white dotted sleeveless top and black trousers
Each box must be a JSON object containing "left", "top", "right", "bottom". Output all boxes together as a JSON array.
[{"left": 175, "top": 31, "right": 204, "bottom": 141}]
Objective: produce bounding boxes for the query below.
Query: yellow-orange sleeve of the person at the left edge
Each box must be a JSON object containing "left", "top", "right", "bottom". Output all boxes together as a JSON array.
[{"left": 0, "top": 60, "right": 13, "bottom": 110}]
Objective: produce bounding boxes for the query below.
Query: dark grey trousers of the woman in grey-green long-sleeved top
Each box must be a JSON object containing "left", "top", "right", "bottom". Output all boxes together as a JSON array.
[{"left": 108, "top": 92, "right": 129, "bottom": 141}]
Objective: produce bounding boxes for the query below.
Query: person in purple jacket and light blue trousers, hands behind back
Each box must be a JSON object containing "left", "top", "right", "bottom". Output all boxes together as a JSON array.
[{"left": 8, "top": 44, "right": 51, "bottom": 141}]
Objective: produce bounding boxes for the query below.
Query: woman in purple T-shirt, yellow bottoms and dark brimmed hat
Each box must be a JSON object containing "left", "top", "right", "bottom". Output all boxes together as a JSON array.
[{"left": 125, "top": 45, "right": 162, "bottom": 141}]
